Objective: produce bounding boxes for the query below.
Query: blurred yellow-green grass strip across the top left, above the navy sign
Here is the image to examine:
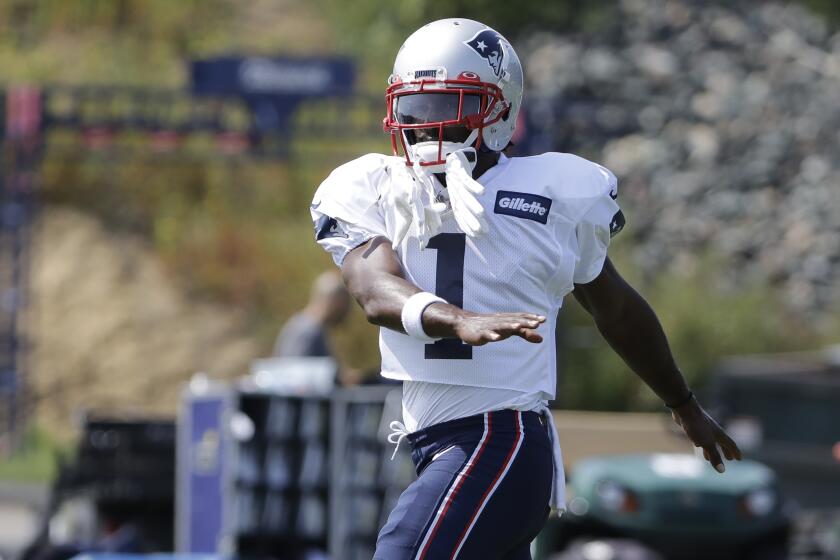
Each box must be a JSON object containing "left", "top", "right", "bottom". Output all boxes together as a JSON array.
[{"left": 0, "top": 0, "right": 334, "bottom": 87}]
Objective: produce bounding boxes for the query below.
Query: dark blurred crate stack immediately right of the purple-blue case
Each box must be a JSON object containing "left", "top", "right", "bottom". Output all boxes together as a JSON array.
[{"left": 233, "top": 391, "right": 329, "bottom": 558}]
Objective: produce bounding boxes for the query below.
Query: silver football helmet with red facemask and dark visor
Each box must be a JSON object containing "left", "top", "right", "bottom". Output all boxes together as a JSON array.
[{"left": 384, "top": 18, "right": 523, "bottom": 172}]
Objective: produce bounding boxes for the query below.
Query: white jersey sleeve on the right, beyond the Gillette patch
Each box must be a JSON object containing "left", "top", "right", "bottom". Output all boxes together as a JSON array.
[{"left": 574, "top": 165, "right": 624, "bottom": 284}]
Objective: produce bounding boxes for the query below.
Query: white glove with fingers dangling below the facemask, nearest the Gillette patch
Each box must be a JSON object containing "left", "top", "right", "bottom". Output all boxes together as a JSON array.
[{"left": 446, "top": 148, "right": 487, "bottom": 237}]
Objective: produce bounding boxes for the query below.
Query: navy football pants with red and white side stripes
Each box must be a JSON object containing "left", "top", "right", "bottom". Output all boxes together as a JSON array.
[{"left": 374, "top": 410, "right": 553, "bottom": 560}]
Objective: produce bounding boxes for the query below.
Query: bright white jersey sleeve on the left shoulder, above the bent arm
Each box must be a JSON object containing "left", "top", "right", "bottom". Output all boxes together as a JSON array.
[{"left": 309, "top": 154, "right": 387, "bottom": 267}]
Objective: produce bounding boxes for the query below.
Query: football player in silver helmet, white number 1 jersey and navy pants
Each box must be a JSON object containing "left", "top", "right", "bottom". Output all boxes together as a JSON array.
[{"left": 311, "top": 19, "right": 740, "bottom": 560}]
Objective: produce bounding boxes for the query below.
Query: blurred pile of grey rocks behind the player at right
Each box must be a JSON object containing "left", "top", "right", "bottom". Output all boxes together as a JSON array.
[{"left": 520, "top": 0, "right": 840, "bottom": 315}]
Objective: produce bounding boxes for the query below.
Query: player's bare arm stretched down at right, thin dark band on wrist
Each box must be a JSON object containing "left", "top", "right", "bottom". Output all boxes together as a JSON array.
[{"left": 573, "top": 258, "right": 741, "bottom": 472}]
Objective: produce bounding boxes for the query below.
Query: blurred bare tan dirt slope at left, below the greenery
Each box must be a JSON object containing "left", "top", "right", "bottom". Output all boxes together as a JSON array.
[{"left": 28, "top": 208, "right": 260, "bottom": 433}]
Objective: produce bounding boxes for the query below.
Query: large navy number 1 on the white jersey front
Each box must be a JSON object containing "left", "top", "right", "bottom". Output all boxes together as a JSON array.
[{"left": 426, "top": 233, "right": 472, "bottom": 360}]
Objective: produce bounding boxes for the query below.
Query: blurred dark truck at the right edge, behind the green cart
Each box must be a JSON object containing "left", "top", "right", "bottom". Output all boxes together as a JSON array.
[{"left": 709, "top": 349, "right": 840, "bottom": 515}]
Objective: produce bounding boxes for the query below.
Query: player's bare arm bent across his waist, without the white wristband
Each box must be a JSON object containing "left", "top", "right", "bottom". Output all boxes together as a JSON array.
[{"left": 341, "top": 236, "right": 545, "bottom": 346}]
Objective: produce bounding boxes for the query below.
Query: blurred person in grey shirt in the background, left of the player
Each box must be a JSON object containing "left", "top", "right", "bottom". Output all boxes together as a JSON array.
[{"left": 274, "top": 270, "right": 362, "bottom": 385}]
